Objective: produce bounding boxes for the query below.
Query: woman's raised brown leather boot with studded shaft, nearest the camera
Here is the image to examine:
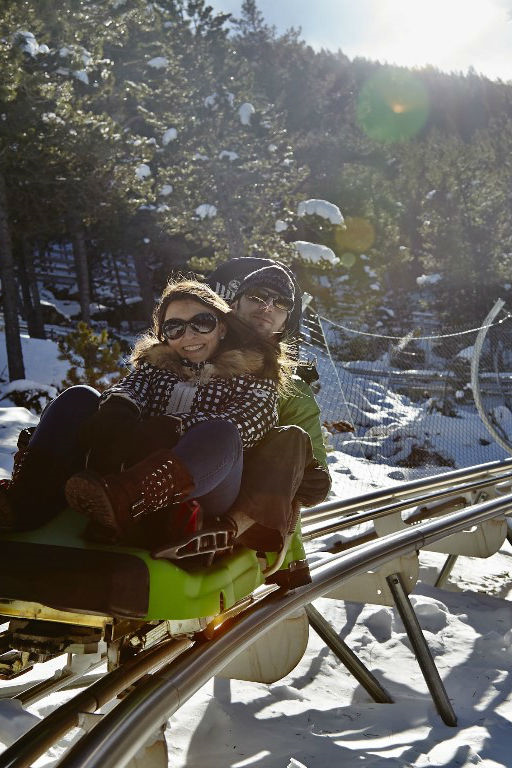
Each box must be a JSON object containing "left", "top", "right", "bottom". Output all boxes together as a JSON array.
[{"left": 66, "top": 448, "right": 194, "bottom": 537}]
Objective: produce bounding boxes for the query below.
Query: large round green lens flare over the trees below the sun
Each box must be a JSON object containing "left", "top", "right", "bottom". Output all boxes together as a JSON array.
[{"left": 357, "top": 68, "right": 429, "bottom": 143}]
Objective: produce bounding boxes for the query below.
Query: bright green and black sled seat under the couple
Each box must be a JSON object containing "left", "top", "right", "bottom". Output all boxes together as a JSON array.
[{"left": 0, "top": 509, "right": 263, "bottom": 621}]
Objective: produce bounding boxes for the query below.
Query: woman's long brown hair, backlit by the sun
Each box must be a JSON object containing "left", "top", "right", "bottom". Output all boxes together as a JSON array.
[{"left": 130, "top": 280, "right": 296, "bottom": 393}]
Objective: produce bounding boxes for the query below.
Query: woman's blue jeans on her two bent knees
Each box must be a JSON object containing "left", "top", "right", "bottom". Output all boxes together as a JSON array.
[{"left": 30, "top": 384, "right": 243, "bottom": 515}]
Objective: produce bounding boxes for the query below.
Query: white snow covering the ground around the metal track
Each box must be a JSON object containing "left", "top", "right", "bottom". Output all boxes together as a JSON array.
[{"left": 0, "top": 332, "right": 512, "bottom": 768}]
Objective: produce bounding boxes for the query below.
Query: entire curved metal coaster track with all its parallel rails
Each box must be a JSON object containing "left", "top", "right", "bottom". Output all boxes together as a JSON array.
[{"left": 0, "top": 460, "right": 512, "bottom": 768}]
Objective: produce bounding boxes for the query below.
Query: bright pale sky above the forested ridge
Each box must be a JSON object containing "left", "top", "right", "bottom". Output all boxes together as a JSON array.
[{"left": 209, "top": 0, "right": 512, "bottom": 80}]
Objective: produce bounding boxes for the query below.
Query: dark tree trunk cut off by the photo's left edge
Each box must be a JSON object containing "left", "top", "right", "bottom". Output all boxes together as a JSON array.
[{"left": 0, "top": 173, "right": 25, "bottom": 381}]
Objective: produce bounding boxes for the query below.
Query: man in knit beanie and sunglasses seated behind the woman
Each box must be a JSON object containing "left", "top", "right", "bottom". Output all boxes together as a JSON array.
[{"left": 209, "top": 257, "right": 330, "bottom": 586}]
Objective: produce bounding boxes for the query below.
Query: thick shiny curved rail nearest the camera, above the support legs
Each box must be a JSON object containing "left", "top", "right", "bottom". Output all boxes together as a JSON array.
[{"left": 55, "top": 494, "right": 512, "bottom": 768}]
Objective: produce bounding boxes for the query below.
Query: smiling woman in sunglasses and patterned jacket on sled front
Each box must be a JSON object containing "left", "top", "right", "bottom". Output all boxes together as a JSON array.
[{"left": 0, "top": 281, "right": 286, "bottom": 554}]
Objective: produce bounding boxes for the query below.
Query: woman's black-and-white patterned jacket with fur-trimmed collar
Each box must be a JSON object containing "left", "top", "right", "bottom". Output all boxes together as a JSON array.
[{"left": 100, "top": 344, "right": 278, "bottom": 448}]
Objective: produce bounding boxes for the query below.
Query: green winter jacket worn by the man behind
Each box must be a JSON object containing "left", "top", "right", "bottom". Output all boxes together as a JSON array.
[{"left": 278, "top": 376, "right": 327, "bottom": 468}]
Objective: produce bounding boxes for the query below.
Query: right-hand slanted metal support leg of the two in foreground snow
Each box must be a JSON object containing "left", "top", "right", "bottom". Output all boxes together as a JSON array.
[{"left": 386, "top": 573, "right": 457, "bottom": 727}]
